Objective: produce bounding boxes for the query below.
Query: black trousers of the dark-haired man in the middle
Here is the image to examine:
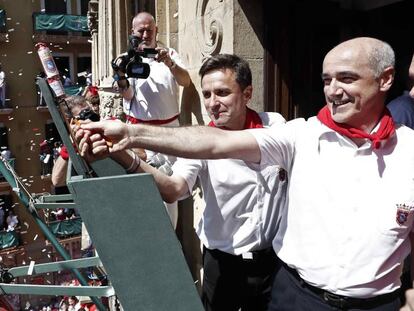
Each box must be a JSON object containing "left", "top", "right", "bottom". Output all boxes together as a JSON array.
[{"left": 202, "top": 247, "right": 278, "bottom": 311}]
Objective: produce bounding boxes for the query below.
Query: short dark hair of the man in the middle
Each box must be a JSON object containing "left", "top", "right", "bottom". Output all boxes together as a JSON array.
[{"left": 198, "top": 54, "right": 252, "bottom": 90}]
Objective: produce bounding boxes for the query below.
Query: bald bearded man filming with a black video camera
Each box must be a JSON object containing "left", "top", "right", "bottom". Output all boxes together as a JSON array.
[{"left": 113, "top": 12, "right": 191, "bottom": 227}]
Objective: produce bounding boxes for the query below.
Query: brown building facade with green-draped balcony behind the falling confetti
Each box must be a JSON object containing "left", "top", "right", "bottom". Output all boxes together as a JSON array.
[{"left": 0, "top": 0, "right": 91, "bottom": 310}]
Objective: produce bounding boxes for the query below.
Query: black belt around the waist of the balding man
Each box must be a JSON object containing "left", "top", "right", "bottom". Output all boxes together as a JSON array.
[{"left": 283, "top": 263, "right": 400, "bottom": 310}]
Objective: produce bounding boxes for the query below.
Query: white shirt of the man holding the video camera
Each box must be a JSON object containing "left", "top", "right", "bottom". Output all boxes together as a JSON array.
[{"left": 123, "top": 48, "right": 184, "bottom": 120}]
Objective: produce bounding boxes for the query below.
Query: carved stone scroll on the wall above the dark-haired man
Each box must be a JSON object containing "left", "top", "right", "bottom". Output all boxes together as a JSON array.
[{"left": 196, "top": 0, "right": 223, "bottom": 57}]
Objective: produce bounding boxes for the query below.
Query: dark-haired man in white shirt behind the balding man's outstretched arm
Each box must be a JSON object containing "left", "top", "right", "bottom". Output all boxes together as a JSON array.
[{"left": 78, "top": 54, "right": 287, "bottom": 311}]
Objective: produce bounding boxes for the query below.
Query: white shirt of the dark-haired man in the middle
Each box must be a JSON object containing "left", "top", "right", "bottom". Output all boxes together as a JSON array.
[{"left": 172, "top": 113, "right": 287, "bottom": 255}]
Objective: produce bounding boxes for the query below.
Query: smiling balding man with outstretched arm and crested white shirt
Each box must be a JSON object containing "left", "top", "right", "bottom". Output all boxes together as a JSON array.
[{"left": 77, "top": 38, "right": 414, "bottom": 311}]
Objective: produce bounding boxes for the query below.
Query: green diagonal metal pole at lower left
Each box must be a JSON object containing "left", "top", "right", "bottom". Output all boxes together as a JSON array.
[{"left": 0, "top": 159, "right": 107, "bottom": 311}]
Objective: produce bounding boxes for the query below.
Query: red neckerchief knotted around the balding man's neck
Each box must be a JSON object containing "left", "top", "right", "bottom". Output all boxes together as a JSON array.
[{"left": 318, "top": 106, "right": 395, "bottom": 149}]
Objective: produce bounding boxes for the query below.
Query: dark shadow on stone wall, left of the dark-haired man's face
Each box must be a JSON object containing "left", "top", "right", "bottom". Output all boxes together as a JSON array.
[{"left": 180, "top": 82, "right": 204, "bottom": 125}]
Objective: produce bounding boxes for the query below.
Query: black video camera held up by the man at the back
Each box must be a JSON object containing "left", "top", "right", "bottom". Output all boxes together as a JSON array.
[{"left": 111, "top": 35, "right": 157, "bottom": 79}]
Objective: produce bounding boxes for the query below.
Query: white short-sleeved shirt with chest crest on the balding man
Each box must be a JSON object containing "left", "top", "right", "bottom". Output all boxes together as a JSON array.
[{"left": 251, "top": 117, "right": 414, "bottom": 297}]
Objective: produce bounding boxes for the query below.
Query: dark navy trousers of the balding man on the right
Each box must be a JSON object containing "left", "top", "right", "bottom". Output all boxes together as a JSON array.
[{"left": 269, "top": 264, "right": 401, "bottom": 311}]
